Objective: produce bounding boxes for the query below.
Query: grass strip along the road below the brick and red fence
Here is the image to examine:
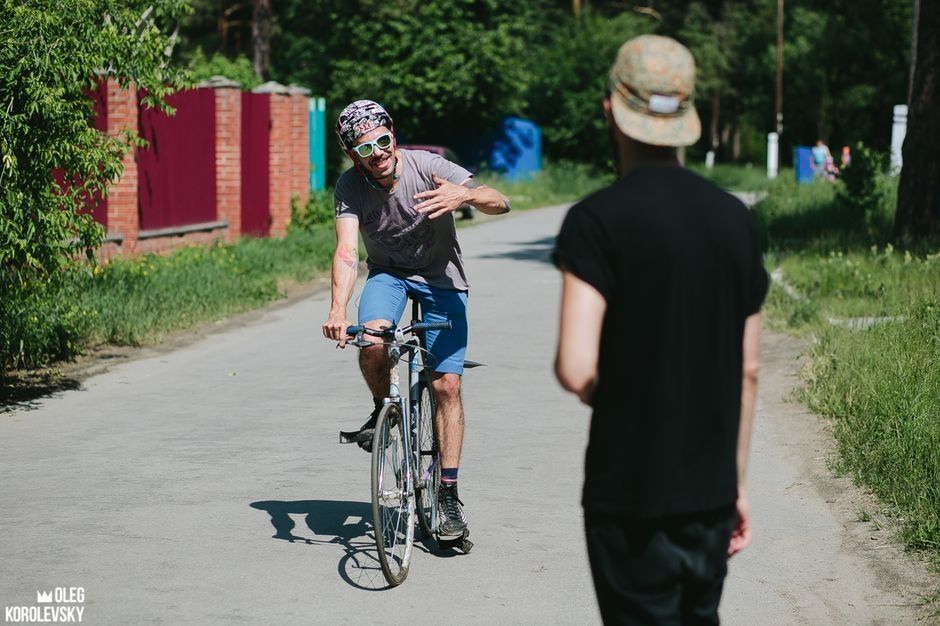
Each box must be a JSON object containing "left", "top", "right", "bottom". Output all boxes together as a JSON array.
[{"left": 0, "top": 225, "right": 335, "bottom": 369}]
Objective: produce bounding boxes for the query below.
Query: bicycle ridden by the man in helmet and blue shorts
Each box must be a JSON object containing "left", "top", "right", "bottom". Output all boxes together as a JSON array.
[{"left": 346, "top": 302, "right": 475, "bottom": 586}]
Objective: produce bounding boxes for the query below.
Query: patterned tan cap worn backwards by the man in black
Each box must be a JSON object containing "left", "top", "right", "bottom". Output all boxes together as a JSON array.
[{"left": 609, "top": 35, "right": 702, "bottom": 146}]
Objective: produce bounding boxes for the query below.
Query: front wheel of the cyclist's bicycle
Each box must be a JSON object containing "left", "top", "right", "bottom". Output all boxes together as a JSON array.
[{"left": 372, "top": 404, "right": 415, "bottom": 586}]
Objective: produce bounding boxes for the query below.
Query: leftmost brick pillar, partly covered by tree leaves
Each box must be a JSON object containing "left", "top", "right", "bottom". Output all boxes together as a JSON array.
[{"left": 107, "top": 78, "right": 140, "bottom": 253}]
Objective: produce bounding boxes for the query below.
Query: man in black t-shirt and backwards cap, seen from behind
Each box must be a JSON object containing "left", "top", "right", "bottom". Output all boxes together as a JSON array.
[{"left": 554, "top": 35, "right": 767, "bottom": 624}]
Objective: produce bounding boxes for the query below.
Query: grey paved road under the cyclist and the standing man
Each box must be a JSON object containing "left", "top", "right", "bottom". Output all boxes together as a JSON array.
[{"left": 0, "top": 204, "right": 932, "bottom": 624}]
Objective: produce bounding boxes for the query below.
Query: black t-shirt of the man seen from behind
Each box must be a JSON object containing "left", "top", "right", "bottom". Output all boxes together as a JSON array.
[{"left": 554, "top": 165, "right": 767, "bottom": 517}]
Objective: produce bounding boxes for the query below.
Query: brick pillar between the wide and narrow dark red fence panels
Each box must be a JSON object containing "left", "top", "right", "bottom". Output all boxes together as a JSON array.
[{"left": 200, "top": 76, "right": 242, "bottom": 243}]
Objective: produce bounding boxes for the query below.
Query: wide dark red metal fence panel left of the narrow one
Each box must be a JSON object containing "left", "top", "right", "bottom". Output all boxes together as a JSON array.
[{"left": 137, "top": 89, "right": 217, "bottom": 230}]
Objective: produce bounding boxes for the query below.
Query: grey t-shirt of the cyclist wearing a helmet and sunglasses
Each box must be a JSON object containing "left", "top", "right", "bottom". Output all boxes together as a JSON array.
[{"left": 333, "top": 150, "right": 472, "bottom": 291}]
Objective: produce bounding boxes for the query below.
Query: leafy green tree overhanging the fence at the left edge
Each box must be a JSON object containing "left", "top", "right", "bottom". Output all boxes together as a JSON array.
[{"left": 0, "top": 0, "right": 191, "bottom": 367}]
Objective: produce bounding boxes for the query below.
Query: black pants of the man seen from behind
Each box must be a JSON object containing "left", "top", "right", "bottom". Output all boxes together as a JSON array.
[{"left": 584, "top": 507, "right": 735, "bottom": 624}]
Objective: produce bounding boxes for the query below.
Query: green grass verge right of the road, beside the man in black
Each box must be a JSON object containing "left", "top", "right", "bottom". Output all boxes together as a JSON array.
[{"left": 755, "top": 169, "right": 940, "bottom": 568}]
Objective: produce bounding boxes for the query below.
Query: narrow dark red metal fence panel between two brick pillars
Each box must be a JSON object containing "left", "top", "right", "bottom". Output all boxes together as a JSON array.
[{"left": 241, "top": 92, "right": 271, "bottom": 237}]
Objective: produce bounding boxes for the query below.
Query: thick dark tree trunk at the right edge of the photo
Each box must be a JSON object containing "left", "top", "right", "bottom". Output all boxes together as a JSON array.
[{"left": 894, "top": 0, "right": 940, "bottom": 246}]
